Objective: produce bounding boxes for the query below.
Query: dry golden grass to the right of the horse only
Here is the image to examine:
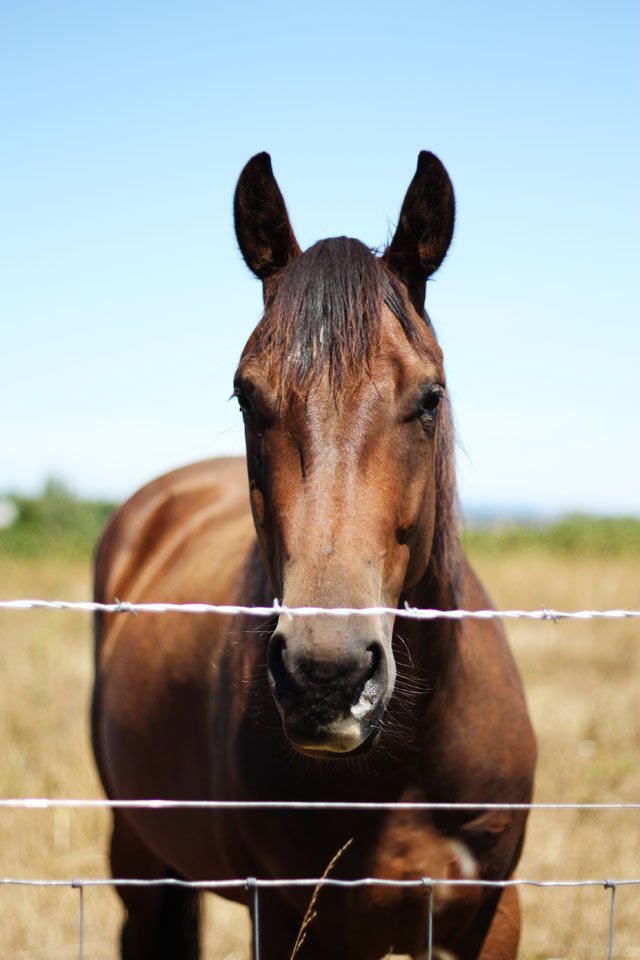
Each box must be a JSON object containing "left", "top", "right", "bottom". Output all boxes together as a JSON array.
[{"left": 474, "top": 551, "right": 640, "bottom": 960}]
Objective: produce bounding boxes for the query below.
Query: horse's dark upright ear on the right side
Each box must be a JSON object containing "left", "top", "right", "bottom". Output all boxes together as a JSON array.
[{"left": 384, "top": 150, "right": 455, "bottom": 314}]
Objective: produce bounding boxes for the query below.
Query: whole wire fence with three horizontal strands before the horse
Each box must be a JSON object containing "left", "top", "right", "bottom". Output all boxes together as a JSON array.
[{"left": 0, "top": 599, "right": 640, "bottom": 960}]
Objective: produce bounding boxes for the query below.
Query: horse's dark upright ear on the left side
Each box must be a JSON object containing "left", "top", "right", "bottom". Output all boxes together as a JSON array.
[{"left": 233, "top": 153, "right": 300, "bottom": 282}]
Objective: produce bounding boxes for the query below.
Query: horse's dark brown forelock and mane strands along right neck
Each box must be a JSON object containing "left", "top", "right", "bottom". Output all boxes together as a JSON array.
[{"left": 246, "top": 237, "right": 461, "bottom": 603}]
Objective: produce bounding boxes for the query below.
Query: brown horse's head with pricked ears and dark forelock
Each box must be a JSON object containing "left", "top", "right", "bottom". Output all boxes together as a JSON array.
[{"left": 235, "top": 152, "right": 454, "bottom": 758}]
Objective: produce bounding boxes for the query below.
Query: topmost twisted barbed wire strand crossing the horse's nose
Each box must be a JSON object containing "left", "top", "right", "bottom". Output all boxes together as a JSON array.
[{"left": 0, "top": 599, "right": 640, "bottom": 622}]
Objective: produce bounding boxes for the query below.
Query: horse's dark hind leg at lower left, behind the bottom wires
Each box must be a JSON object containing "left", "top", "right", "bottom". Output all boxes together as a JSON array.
[{"left": 111, "top": 810, "right": 200, "bottom": 960}]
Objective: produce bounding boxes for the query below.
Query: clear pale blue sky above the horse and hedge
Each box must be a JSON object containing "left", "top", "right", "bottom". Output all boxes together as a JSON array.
[{"left": 0, "top": 0, "right": 640, "bottom": 514}]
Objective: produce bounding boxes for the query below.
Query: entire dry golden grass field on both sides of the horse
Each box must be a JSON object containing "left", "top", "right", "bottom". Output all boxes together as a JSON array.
[{"left": 0, "top": 550, "right": 640, "bottom": 960}]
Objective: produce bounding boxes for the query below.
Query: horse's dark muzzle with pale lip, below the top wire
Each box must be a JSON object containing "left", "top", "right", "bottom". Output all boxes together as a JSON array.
[{"left": 268, "top": 618, "right": 395, "bottom": 759}]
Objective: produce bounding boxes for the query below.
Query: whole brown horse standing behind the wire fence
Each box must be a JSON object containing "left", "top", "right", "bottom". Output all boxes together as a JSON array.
[{"left": 93, "top": 152, "right": 535, "bottom": 960}]
